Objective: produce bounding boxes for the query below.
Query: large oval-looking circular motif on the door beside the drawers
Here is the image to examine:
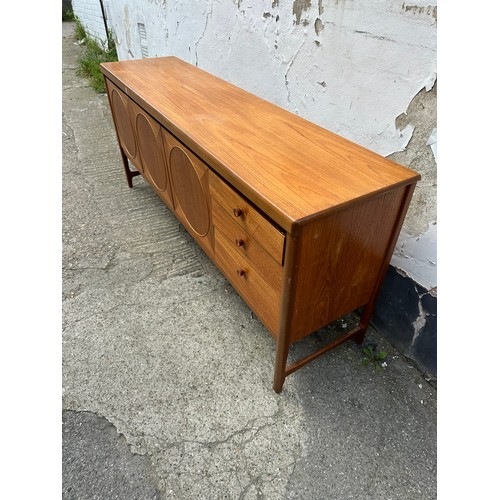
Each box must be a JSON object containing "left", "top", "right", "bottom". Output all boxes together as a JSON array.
[{"left": 170, "top": 147, "right": 210, "bottom": 236}]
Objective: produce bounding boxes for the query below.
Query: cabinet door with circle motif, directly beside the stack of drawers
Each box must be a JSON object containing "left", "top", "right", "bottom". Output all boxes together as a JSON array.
[{"left": 162, "top": 128, "right": 213, "bottom": 258}]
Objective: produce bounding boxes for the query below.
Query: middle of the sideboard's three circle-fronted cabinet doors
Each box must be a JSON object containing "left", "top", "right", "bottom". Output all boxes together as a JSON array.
[{"left": 129, "top": 101, "right": 173, "bottom": 208}]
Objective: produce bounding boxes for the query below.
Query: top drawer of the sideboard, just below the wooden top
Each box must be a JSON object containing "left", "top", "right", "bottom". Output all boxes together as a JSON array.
[{"left": 210, "top": 173, "right": 285, "bottom": 265}]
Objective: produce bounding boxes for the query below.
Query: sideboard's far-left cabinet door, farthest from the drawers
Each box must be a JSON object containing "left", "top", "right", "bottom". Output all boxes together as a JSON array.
[{"left": 106, "top": 79, "right": 143, "bottom": 173}]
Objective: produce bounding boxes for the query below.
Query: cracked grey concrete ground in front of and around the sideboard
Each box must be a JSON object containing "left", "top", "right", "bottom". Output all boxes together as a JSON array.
[{"left": 62, "top": 23, "right": 437, "bottom": 500}]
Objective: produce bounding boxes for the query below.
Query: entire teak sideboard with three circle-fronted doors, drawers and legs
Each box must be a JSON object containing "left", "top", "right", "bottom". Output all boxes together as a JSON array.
[{"left": 101, "top": 57, "right": 420, "bottom": 393}]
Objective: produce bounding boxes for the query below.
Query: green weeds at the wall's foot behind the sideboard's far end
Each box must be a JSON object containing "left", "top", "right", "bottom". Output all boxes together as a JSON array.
[{"left": 75, "top": 19, "right": 118, "bottom": 94}]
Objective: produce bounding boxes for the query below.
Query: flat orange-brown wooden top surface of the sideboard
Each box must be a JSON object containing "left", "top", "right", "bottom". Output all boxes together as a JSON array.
[{"left": 101, "top": 57, "right": 420, "bottom": 231}]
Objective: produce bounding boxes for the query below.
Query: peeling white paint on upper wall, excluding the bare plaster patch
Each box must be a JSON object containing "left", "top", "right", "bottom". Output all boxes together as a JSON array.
[{"left": 105, "top": 0, "right": 436, "bottom": 156}]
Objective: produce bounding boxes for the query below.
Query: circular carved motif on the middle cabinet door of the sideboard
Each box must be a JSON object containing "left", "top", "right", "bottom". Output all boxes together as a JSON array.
[{"left": 135, "top": 113, "right": 167, "bottom": 191}]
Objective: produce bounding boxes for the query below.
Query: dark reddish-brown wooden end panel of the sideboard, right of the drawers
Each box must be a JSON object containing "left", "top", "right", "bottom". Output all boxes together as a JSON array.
[{"left": 290, "top": 187, "right": 405, "bottom": 342}]
